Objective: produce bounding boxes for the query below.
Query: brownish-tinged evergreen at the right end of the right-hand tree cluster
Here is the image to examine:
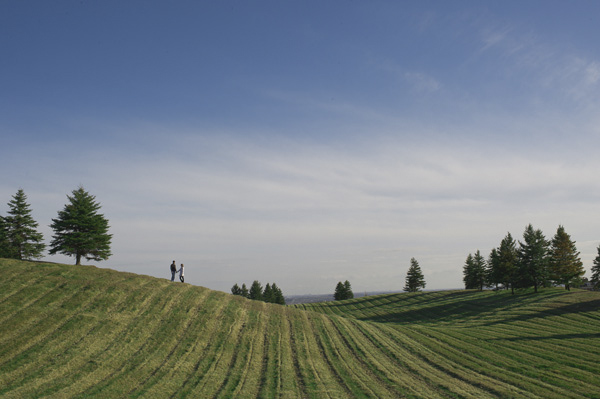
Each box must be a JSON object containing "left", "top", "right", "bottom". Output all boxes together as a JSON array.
[{"left": 549, "top": 226, "right": 585, "bottom": 291}]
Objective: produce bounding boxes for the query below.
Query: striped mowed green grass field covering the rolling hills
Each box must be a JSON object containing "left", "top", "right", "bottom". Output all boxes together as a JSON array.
[{"left": 0, "top": 259, "right": 600, "bottom": 398}]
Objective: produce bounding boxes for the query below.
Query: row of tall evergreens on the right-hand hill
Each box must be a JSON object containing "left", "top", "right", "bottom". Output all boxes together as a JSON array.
[{"left": 463, "top": 224, "right": 600, "bottom": 294}]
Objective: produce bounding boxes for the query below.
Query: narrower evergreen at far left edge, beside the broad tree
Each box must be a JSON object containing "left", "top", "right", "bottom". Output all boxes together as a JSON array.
[{"left": 4, "top": 189, "right": 46, "bottom": 259}]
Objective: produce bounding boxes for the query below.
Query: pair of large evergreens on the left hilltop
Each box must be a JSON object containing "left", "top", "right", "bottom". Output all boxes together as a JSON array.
[{"left": 0, "top": 186, "right": 112, "bottom": 265}]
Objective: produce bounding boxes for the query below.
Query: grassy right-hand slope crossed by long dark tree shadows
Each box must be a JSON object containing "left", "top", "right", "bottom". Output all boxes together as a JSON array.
[{"left": 296, "top": 288, "right": 600, "bottom": 398}]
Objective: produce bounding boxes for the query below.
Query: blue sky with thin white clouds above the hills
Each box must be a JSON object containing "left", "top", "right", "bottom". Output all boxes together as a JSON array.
[{"left": 0, "top": 1, "right": 600, "bottom": 294}]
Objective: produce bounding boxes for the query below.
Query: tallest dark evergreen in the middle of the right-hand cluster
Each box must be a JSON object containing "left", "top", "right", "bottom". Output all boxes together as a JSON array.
[{"left": 517, "top": 224, "right": 549, "bottom": 292}]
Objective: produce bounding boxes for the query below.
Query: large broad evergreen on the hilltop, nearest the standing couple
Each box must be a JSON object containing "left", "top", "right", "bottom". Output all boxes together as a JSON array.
[{"left": 50, "top": 186, "right": 112, "bottom": 265}]
